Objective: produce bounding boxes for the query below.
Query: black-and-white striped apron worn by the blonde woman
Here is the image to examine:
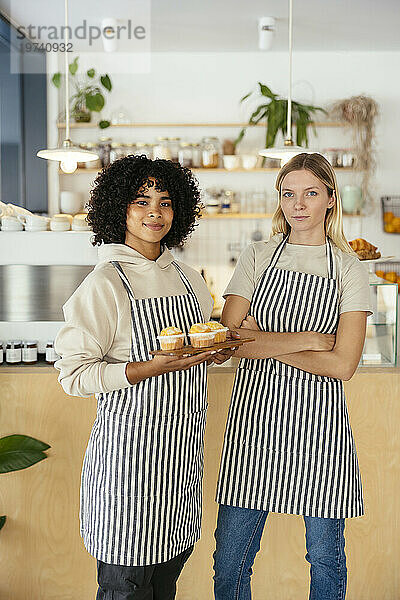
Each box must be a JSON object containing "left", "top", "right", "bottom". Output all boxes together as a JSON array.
[{"left": 217, "top": 236, "right": 364, "bottom": 519}]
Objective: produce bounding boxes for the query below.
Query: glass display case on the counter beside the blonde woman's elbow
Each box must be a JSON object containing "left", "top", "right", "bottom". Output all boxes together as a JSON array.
[{"left": 360, "top": 273, "right": 398, "bottom": 367}]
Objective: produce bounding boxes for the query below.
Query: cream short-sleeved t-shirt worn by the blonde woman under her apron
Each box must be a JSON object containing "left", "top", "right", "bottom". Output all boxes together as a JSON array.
[{"left": 224, "top": 233, "right": 372, "bottom": 314}]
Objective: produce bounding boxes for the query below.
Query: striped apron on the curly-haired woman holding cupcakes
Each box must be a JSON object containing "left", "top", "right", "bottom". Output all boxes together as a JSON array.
[{"left": 80, "top": 262, "right": 207, "bottom": 566}]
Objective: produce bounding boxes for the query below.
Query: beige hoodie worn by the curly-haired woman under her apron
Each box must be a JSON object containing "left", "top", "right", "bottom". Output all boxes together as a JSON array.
[{"left": 55, "top": 244, "right": 213, "bottom": 396}]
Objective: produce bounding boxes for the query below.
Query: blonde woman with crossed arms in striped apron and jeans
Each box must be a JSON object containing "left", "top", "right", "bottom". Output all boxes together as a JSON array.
[{"left": 214, "top": 154, "right": 371, "bottom": 600}]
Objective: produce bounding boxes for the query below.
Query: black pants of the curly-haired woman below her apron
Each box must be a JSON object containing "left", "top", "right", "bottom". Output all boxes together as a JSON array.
[{"left": 96, "top": 546, "right": 194, "bottom": 600}]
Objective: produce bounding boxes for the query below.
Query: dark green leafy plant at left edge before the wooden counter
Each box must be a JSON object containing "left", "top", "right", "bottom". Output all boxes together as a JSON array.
[{"left": 0, "top": 434, "right": 50, "bottom": 529}]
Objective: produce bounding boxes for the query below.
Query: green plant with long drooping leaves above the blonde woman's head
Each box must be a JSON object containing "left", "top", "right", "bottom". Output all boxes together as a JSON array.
[{"left": 235, "top": 82, "right": 327, "bottom": 148}]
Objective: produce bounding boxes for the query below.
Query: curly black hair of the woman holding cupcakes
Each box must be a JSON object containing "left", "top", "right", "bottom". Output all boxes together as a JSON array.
[{"left": 87, "top": 155, "right": 201, "bottom": 248}]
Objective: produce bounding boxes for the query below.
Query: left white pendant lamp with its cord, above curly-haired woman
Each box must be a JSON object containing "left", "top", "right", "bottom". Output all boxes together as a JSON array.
[{"left": 37, "top": 0, "right": 99, "bottom": 173}]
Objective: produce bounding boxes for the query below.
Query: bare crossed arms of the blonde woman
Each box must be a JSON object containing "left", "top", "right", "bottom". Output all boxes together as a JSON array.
[{"left": 221, "top": 295, "right": 367, "bottom": 381}]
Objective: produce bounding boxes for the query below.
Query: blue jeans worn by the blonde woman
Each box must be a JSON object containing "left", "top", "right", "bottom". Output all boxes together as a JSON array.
[{"left": 214, "top": 505, "right": 347, "bottom": 600}]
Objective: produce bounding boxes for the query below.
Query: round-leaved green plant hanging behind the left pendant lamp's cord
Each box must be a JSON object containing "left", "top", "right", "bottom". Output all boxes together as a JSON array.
[{"left": 52, "top": 56, "right": 112, "bottom": 129}]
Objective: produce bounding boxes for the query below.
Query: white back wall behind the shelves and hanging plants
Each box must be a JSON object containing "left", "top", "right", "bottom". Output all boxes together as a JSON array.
[{"left": 50, "top": 51, "right": 400, "bottom": 302}]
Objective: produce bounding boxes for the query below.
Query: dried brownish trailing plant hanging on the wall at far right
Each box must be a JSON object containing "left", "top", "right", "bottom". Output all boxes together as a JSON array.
[{"left": 330, "top": 96, "right": 379, "bottom": 202}]
